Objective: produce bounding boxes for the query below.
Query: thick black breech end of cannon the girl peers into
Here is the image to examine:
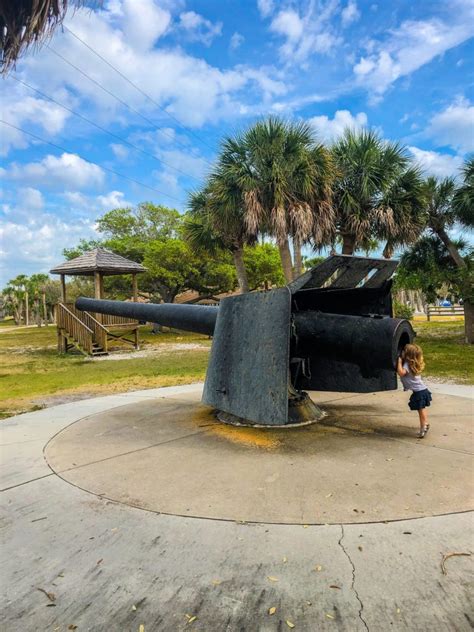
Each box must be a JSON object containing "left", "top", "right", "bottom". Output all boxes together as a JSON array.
[{"left": 293, "top": 311, "right": 413, "bottom": 369}]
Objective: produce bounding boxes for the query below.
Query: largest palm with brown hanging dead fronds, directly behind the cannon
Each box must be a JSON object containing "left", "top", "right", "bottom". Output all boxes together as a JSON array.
[{"left": 219, "top": 117, "right": 334, "bottom": 282}]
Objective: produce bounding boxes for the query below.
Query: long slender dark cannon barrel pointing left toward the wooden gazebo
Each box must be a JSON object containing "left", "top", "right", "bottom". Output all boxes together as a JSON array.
[{"left": 76, "top": 297, "right": 218, "bottom": 336}]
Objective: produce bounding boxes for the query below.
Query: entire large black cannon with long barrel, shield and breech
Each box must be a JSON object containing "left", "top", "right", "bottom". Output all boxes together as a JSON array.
[{"left": 76, "top": 255, "right": 415, "bottom": 426}]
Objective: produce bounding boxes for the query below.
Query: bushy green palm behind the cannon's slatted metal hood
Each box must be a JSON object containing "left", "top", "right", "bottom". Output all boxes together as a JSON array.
[{"left": 331, "top": 129, "right": 423, "bottom": 257}]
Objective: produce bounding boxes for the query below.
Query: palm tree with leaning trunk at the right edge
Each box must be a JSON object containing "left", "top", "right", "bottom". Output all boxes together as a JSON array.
[{"left": 424, "top": 173, "right": 474, "bottom": 344}]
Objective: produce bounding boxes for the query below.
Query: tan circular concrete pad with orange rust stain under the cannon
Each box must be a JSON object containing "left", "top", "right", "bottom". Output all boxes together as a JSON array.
[{"left": 45, "top": 391, "right": 472, "bottom": 524}]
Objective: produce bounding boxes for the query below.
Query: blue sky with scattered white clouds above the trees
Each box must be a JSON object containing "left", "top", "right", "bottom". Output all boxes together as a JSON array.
[{"left": 0, "top": 0, "right": 474, "bottom": 286}]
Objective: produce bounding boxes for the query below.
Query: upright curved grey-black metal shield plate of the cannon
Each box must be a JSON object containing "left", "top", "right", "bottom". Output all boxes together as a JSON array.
[{"left": 203, "top": 287, "right": 291, "bottom": 426}]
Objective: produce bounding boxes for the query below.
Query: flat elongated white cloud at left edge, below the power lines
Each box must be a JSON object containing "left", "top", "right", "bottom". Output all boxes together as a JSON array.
[{"left": 2, "top": 153, "right": 104, "bottom": 189}]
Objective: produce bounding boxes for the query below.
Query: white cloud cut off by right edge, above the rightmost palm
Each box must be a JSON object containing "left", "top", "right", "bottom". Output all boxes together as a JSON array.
[{"left": 426, "top": 98, "right": 474, "bottom": 153}]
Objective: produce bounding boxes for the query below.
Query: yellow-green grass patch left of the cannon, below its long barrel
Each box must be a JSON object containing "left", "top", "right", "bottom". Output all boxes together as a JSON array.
[{"left": 0, "top": 326, "right": 210, "bottom": 418}]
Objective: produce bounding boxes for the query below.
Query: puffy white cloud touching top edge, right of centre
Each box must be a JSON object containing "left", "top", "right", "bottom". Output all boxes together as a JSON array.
[{"left": 270, "top": 0, "right": 341, "bottom": 62}]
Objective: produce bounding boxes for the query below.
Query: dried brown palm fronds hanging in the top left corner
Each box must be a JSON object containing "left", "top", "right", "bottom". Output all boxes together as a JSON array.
[{"left": 0, "top": 0, "right": 84, "bottom": 73}]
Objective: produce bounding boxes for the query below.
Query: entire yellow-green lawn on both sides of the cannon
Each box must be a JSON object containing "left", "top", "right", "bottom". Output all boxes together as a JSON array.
[{"left": 0, "top": 322, "right": 474, "bottom": 418}]
